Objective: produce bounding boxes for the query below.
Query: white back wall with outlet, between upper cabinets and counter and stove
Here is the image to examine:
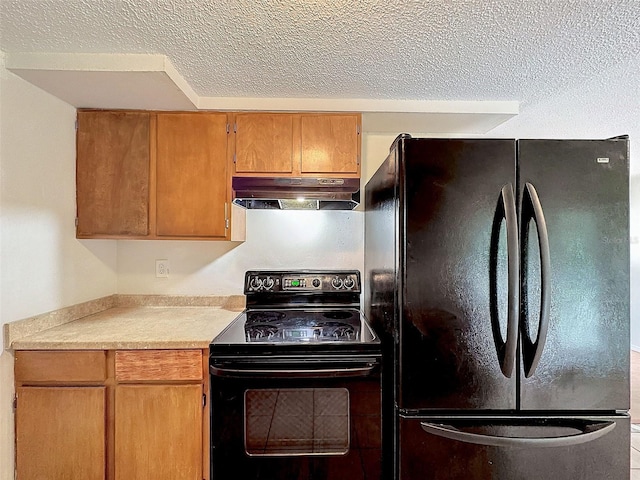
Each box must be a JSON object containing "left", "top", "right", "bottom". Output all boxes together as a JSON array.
[{"left": 118, "top": 210, "right": 364, "bottom": 295}]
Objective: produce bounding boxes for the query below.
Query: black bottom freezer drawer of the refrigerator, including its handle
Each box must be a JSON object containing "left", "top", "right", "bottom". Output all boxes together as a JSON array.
[{"left": 399, "top": 415, "right": 631, "bottom": 480}]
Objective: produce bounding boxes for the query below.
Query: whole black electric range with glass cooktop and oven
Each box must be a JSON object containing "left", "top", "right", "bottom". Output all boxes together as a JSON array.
[{"left": 209, "top": 270, "right": 382, "bottom": 480}]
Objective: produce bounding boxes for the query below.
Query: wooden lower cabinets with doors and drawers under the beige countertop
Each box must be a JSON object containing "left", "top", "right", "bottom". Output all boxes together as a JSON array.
[{"left": 15, "top": 349, "right": 209, "bottom": 480}]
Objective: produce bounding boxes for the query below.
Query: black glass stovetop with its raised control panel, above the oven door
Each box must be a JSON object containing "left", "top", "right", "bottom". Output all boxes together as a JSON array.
[{"left": 211, "top": 270, "right": 379, "bottom": 353}]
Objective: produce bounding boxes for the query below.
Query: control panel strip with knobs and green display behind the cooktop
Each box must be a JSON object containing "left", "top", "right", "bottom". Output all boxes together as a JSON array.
[{"left": 244, "top": 270, "right": 360, "bottom": 294}]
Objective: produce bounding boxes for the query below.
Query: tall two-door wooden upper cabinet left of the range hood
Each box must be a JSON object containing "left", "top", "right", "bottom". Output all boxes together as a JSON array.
[{"left": 76, "top": 110, "right": 244, "bottom": 241}]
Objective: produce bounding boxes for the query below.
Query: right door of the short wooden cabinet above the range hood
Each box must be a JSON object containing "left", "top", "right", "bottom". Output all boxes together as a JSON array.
[{"left": 300, "top": 114, "right": 360, "bottom": 175}]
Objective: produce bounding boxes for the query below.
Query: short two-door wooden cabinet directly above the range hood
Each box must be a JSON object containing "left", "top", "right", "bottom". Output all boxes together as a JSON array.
[{"left": 234, "top": 113, "right": 362, "bottom": 178}]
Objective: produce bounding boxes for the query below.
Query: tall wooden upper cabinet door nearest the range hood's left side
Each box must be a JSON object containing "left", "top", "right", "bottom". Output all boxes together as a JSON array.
[{"left": 156, "top": 113, "right": 229, "bottom": 238}]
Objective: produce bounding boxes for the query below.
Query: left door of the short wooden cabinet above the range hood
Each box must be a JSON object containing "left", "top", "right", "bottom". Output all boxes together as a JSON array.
[{"left": 235, "top": 113, "right": 294, "bottom": 173}]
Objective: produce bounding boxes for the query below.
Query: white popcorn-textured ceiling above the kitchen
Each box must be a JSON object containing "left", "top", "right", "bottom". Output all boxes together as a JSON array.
[{"left": 0, "top": 0, "right": 640, "bottom": 108}]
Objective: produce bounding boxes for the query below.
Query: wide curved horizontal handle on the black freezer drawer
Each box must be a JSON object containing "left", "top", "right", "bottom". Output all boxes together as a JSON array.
[{"left": 420, "top": 422, "right": 616, "bottom": 447}]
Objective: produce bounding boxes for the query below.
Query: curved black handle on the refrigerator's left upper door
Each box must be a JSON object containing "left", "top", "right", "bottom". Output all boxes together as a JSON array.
[{"left": 490, "top": 183, "right": 520, "bottom": 378}]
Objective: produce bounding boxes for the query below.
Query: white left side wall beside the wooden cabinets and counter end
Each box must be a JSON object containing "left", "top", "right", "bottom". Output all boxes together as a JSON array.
[{"left": 0, "top": 57, "right": 116, "bottom": 479}]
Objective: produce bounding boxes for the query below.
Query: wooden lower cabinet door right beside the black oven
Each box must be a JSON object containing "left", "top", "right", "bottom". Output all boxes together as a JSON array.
[{"left": 115, "top": 384, "right": 203, "bottom": 480}]
